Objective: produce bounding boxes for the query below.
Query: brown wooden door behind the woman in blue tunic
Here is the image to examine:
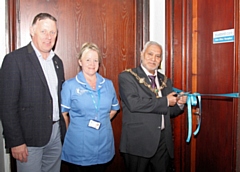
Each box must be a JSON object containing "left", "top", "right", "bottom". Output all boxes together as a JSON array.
[{"left": 8, "top": 0, "right": 148, "bottom": 172}]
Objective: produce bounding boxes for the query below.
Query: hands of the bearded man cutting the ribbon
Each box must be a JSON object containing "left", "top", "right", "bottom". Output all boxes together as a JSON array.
[{"left": 167, "top": 92, "right": 187, "bottom": 106}]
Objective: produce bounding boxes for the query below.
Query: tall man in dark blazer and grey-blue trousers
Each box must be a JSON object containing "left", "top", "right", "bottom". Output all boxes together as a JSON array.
[{"left": 0, "top": 13, "right": 66, "bottom": 172}]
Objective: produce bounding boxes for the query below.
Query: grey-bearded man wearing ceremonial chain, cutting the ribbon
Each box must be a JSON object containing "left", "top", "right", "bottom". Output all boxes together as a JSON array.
[{"left": 118, "top": 41, "right": 187, "bottom": 172}]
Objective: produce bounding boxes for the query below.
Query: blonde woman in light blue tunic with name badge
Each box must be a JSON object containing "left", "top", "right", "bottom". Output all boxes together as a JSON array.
[{"left": 61, "top": 43, "right": 120, "bottom": 172}]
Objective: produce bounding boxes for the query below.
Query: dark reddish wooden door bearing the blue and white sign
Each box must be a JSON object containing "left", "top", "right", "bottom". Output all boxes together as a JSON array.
[{"left": 194, "top": 0, "right": 239, "bottom": 172}]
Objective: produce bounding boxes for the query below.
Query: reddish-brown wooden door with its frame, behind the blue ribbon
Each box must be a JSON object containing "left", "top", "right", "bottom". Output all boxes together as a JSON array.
[{"left": 166, "top": 0, "right": 240, "bottom": 172}]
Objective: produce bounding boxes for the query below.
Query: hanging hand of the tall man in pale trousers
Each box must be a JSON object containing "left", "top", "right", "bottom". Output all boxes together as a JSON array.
[{"left": 11, "top": 144, "right": 28, "bottom": 162}]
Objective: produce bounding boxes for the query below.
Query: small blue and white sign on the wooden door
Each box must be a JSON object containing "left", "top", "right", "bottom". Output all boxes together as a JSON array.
[{"left": 213, "top": 29, "right": 234, "bottom": 44}]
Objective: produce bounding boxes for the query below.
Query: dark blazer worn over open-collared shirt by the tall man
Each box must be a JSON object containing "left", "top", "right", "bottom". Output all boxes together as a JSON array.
[{"left": 0, "top": 44, "right": 66, "bottom": 148}]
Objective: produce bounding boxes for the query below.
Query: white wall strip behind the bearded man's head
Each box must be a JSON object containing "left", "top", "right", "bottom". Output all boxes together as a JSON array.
[{"left": 149, "top": 0, "right": 165, "bottom": 74}]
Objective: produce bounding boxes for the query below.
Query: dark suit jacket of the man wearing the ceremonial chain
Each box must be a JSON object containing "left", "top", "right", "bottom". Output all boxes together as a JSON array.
[{"left": 118, "top": 67, "right": 183, "bottom": 158}]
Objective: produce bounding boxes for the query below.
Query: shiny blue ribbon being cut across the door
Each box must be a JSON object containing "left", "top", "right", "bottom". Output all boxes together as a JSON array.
[{"left": 173, "top": 88, "right": 239, "bottom": 142}]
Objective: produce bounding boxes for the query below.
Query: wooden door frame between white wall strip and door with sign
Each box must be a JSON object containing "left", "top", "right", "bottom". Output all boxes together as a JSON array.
[{"left": 165, "top": 0, "right": 192, "bottom": 171}]
